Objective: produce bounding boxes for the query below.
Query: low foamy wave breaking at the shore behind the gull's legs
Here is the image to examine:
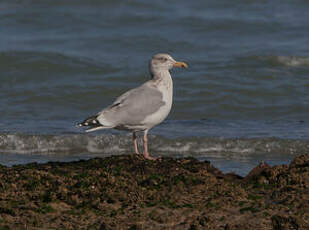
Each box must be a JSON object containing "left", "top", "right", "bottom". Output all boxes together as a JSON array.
[{"left": 0, "top": 134, "right": 309, "bottom": 156}]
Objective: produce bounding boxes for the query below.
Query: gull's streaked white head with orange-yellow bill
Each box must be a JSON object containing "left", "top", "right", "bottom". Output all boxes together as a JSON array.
[{"left": 150, "top": 53, "right": 188, "bottom": 72}]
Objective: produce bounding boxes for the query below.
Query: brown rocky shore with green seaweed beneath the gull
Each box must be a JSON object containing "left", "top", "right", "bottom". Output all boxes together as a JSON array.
[{"left": 0, "top": 154, "right": 309, "bottom": 230}]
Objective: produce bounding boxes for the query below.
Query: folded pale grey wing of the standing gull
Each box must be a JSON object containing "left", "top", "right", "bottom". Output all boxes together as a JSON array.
[{"left": 98, "top": 84, "right": 165, "bottom": 127}]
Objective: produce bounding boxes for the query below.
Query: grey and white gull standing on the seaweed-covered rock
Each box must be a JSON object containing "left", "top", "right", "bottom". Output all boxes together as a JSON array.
[{"left": 78, "top": 53, "right": 188, "bottom": 160}]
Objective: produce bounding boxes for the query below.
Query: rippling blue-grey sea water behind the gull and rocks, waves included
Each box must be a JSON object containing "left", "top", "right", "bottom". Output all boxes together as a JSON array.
[{"left": 0, "top": 0, "right": 309, "bottom": 173}]
